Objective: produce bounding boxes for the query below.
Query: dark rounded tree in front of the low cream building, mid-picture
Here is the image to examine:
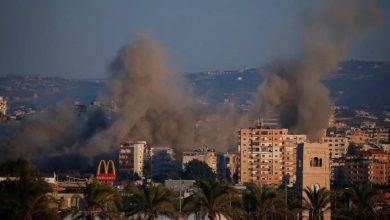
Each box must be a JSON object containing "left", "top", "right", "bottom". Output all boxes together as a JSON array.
[{"left": 182, "top": 160, "right": 216, "bottom": 181}]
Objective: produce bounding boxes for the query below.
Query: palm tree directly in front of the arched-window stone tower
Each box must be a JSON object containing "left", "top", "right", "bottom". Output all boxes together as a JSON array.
[{"left": 303, "top": 187, "right": 332, "bottom": 220}]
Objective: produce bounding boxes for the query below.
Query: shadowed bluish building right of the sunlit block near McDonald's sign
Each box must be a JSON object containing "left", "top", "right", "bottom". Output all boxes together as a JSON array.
[{"left": 150, "top": 147, "right": 176, "bottom": 179}]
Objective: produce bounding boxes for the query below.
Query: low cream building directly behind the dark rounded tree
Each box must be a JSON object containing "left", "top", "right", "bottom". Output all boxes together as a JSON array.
[{"left": 182, "top": 146, "right": 217, "bottom": 173}]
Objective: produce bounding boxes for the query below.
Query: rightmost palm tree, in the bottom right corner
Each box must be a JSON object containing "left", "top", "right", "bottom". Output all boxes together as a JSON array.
[{"left": 345, "top": 186, "right": 384, "bottom": 219}]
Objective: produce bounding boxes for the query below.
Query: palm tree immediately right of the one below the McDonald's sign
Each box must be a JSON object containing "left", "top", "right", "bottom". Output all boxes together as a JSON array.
[{"left": 125, "top": 183, "right": 178, "bottom": 220}]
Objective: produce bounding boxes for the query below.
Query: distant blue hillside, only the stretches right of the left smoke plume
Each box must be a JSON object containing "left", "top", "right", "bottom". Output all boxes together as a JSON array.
[{"left": 187, "top": 60, "right": 390, "bottom": 109}]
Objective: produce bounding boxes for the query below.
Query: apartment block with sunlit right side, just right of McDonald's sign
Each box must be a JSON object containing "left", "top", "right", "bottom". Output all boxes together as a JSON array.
[{"left": 119, "top": 141, "right": 150, "bottom": 176}]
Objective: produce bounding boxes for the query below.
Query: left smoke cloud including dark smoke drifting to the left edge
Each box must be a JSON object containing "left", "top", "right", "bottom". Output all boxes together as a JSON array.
[{"left": 0, "top": 35, "right": 246, "bottom": 169}]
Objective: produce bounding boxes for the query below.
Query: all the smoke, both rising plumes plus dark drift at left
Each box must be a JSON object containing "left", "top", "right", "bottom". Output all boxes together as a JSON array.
[{"left": 0, "top": 1, "right": 380, "bottom": 169}]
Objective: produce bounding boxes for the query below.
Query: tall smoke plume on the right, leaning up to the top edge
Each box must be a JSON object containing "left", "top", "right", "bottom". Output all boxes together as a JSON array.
[{"left": 257, "top": 0, "right": 381, "bottom": 140}]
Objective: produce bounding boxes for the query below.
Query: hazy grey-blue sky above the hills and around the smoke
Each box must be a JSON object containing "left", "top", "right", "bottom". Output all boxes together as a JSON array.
[{"left": 0, "top": 0, "right": 390, "bottom": 78}]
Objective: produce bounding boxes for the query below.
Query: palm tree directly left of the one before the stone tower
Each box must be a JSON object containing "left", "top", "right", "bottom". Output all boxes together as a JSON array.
[{"left": 244, "top": 185, "right": 286, "bottom": 220}]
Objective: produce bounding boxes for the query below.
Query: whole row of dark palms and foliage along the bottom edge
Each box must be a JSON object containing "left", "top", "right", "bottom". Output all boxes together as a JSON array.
[{"left": 0, "top": 160, "right": 390, "bottom": 220}]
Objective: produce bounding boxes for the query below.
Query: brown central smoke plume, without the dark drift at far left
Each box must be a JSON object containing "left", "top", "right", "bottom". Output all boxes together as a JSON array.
[{"left": 85, "top": 35, "right": 247, "bottom": 155}]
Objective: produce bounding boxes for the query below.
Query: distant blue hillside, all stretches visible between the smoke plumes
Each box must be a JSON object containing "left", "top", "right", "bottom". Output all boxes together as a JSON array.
[{"left": 0, "top": 60, "right": 390, "bottom": 109}]
